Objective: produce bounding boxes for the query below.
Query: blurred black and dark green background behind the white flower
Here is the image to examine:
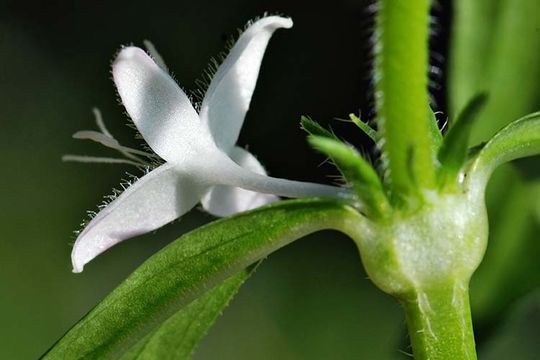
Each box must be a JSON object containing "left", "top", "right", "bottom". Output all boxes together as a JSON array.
[{"left": 0, "top": 0, "right": 540, "bottom": 360}]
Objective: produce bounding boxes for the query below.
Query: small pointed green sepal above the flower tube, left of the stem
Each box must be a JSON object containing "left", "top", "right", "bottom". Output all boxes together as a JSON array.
[{"left": 308, "top": 135, "right": 389, "bottom": 217}]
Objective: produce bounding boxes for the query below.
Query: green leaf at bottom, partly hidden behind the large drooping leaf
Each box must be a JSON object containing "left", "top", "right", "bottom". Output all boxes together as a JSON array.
[{"left": 121, "top": 266, "right": 256, "bottom": 360}]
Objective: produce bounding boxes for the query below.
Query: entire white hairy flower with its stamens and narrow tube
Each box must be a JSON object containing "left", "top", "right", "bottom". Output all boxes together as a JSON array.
[{"left": 71, "top": 16, "right": 342, "bottom": 272}]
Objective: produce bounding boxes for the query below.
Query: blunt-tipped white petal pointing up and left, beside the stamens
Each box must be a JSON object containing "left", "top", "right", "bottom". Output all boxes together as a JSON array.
[{"left": 112, "top": 47, "right": 212, "bottom": 163}]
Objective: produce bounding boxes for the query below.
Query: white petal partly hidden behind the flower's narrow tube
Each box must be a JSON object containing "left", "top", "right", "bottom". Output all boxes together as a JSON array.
[{"left": 201, "top": 146, "right": 279, "bottom": 216}]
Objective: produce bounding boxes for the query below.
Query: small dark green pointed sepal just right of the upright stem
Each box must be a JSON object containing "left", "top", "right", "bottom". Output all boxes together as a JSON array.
[{"left": 438, "top": 93, "right": 487, "bottom": 186}]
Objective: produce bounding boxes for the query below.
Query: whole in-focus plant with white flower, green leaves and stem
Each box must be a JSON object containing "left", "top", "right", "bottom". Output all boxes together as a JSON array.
[{"left": 44, "top": 0, "right": 540, "bottom": 360}]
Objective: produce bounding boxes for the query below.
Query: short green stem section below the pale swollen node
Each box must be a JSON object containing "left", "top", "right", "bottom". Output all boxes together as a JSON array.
[{"left": 402, "top": 281, "right": 476, "bottom": 360}]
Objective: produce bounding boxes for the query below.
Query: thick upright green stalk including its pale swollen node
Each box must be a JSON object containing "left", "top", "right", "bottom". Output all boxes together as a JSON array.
[{"left": 372, "top": 0, "right": 484, "bottom": 360}]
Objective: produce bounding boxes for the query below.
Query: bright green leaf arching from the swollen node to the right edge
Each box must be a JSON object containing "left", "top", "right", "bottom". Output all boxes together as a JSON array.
[{"left": 470, "top": 112, "right": 540, "bottom": 186}]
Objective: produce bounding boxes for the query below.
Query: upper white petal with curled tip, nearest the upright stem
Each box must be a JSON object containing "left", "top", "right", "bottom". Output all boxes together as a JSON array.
[{"left": 199, "top": 16, "right": 292, "bottom": 152}]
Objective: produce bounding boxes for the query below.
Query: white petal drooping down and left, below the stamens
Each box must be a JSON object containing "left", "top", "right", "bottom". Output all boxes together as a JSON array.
[{"left": 71, "top": 164, "right": 206, "bottom": 272}]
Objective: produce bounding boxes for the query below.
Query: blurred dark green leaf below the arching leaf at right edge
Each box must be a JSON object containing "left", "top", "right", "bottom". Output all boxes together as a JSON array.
[{"left": 470, "top": 165, "right": 540, "bottom": 321}]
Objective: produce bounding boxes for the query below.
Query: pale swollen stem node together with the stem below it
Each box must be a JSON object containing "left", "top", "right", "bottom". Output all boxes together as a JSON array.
[{"left": 350, "top": 189, "right": 488, "bottom": 360}]
